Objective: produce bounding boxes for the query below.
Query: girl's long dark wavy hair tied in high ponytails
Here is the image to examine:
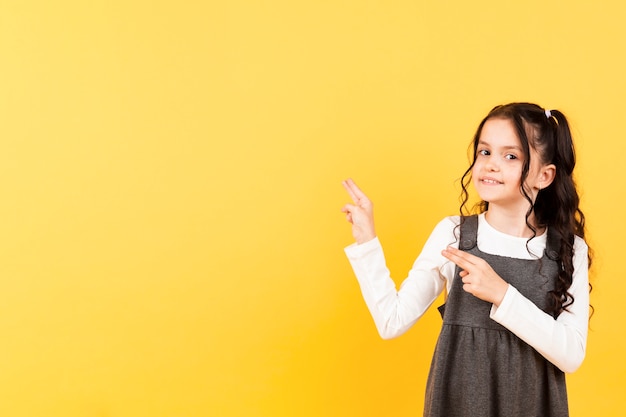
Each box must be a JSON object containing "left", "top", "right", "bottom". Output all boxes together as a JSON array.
[{"left": 460, "top": 103, "right": 591, "bottom": 317}]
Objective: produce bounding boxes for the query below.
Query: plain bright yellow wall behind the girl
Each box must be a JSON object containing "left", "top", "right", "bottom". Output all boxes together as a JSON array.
[{"left": 0, "top": 0, "right": 626, "bottom": 417}]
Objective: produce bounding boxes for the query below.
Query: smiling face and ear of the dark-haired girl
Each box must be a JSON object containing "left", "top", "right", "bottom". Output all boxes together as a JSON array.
[{"left": 472, "top": 118, "right": 547, "bottom": 212}]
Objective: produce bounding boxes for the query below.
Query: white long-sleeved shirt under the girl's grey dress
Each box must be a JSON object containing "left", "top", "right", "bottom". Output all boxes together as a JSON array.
[{"left": 345, "top": 213, "right": 589, "bottom": 372}]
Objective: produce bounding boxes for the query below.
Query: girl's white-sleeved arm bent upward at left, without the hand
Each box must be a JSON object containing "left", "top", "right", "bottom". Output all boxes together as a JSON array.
[{"left": 345, "top": 217, "right": 458, "bottom": 339}]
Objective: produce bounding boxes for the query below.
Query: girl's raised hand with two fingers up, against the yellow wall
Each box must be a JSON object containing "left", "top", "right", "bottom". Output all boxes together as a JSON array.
[{"left": 341, "top": 178, "right": 376, "bottom": 244}]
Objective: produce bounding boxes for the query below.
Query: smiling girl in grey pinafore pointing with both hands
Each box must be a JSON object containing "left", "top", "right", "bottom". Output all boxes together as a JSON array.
[{"left": 342, "top": 103, "right": 589, "bottom": 417}]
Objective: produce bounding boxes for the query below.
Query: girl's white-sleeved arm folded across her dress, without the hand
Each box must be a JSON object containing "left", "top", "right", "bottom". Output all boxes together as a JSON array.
[{"left": 491, "top": 237, "right": 589, "bottom": 372}]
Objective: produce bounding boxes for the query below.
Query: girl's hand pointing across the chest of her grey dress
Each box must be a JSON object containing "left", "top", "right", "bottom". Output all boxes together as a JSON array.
[{"left": 441, "top": 247, "right": 509, "bottom": 307}]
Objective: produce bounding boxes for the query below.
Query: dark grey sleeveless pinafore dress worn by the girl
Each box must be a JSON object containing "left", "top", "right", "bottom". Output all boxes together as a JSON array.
[{"left": 424, "top": 216, "right": 568, "bottom": 417}]
